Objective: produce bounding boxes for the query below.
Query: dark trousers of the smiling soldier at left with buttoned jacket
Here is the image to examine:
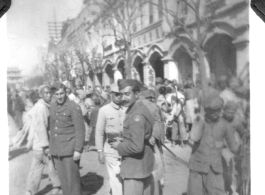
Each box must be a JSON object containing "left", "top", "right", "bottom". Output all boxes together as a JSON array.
[{"left": 52, "top": 156, "right": 81, "bottom": 195}]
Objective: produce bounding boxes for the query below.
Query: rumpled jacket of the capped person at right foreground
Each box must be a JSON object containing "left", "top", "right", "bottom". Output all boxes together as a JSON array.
[{"left": 189, "top": 118, "right": 239, "bottom": 173}]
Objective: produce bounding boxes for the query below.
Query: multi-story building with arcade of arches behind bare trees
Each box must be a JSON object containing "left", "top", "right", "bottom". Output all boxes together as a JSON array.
[{"left": 57, "top": 0, "right": 249, "bottom": 86}]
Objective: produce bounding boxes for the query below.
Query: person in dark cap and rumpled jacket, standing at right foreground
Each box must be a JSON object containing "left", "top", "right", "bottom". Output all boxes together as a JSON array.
[{"left": 187, "top": 95, "right": 239, "bottom": 195}]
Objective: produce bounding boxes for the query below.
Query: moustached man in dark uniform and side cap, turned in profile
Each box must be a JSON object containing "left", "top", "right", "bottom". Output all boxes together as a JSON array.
[{"left": 111, "top": 79, "right": 155, "bottom": 195}]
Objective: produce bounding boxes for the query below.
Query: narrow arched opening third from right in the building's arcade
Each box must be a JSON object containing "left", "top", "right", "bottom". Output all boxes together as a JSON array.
[{"left": 149, "top": 52, "right": 164, "bottom": 79}]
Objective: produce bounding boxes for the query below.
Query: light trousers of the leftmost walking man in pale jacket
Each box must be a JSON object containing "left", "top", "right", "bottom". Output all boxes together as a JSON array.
[{"left": 26, "top": 150, "right": 61, "bottom": 194}]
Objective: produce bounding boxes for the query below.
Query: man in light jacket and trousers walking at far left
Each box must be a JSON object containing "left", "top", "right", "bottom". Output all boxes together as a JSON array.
[{"left": 25, "top": 85, "right": 61, "bottom": 195}]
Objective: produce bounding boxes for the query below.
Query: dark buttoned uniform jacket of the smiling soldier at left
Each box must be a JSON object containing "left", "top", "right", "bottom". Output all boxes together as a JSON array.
[{"left": 50, "top": 98, "right": 85, "bottom": 156}]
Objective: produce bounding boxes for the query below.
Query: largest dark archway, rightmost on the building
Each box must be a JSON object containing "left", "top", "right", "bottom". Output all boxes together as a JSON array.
[{"left": 205, "top": 34, "right": 237, "bottom": 78}]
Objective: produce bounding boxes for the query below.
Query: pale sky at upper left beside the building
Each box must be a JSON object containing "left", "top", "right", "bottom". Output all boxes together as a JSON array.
[{"left": 6, "top": 0, "right": 83, "bottom": 74}]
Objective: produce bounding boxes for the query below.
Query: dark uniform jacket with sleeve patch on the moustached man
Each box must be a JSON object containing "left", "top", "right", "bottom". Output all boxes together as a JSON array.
[{"left": 117, "top": 101, "right": 155, "bottom": 179}]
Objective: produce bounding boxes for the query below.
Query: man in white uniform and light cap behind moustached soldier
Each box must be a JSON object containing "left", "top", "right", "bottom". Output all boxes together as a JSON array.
[{"left": 96, "top": 83, "right": 125, "bottom": 195}]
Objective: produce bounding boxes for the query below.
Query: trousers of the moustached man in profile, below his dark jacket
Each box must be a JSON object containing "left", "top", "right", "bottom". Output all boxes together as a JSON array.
[{"left": 123, "top": 174, "right": 154, "bottom": 195}]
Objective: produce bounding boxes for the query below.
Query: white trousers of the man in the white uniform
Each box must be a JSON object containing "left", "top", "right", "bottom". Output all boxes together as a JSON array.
[{"left": 105, "top": 156, "right": 122, "bottom": 195}]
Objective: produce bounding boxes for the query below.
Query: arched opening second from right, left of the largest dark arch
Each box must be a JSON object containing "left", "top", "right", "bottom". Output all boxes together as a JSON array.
[{"left": 173, "top": 47, "right": 193, "bottom": 83}]
